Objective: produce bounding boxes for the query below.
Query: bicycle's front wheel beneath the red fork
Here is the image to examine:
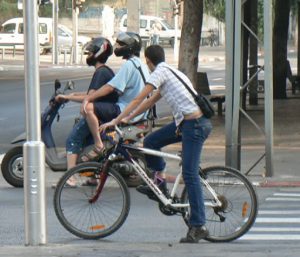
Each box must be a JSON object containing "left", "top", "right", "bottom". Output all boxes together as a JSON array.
[{"left": 54, "top": 162, "right": 130, "bottom": 239}]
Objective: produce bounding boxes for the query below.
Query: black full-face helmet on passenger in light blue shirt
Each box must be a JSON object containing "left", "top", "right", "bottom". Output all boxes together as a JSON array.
[{"left": 114, "top": 32, "right": 142, "bottom": 59}]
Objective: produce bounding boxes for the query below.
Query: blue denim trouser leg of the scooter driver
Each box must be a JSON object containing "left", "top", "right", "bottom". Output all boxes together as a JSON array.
[{"left": 66, "top": 118, "right": 93, "bottom": 154}]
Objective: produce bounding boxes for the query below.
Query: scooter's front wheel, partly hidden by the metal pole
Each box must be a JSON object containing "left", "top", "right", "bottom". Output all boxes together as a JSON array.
[{"left": 1, "top": 146, "right": 24, "bottom": 187}]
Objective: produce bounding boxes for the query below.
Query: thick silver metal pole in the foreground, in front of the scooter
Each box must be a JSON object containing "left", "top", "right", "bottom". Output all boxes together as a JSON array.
[{"left": 23, "top": 1, "right": 47, "bottom": 246}]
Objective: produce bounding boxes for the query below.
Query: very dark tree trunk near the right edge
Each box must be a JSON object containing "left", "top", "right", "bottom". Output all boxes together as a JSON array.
[{"left": 273, "top": 0, "right": 290, "bottom": 99}]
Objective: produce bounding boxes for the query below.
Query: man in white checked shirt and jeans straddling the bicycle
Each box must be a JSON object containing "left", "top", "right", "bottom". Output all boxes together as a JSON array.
[{"left": 100, "top": 45, "right": 212, "bottom": 243}]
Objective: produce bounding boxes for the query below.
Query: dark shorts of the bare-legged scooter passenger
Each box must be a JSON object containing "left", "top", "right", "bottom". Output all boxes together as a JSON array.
[{"left": 94, "top": 102, "right": 121, "bottom": 123}]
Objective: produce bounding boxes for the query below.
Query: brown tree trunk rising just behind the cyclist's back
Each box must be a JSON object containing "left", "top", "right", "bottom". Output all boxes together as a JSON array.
[{"left": 178, "top": 0, "right": 203, "bottom": 86}]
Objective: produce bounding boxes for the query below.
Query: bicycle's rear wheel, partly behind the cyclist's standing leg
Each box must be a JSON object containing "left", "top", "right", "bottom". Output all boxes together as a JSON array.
[{"left": 181, "top": 166, "right": 258, "bottom": 242}]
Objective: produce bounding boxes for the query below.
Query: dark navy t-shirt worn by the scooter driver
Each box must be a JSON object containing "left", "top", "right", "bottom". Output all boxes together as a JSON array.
[{"left": 88, "top": 65, "right": 119, "bottom": 103}]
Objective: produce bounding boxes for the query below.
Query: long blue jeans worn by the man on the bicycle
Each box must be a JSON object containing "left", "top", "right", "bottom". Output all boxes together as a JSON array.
[{"left": 144, "top": 116, "right": 212, "bottom": 226}]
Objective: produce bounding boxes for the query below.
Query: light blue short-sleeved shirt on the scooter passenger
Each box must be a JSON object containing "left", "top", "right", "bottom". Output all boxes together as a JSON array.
[{"left": 108, "top": 56, "right": 150, "bottom": 121}]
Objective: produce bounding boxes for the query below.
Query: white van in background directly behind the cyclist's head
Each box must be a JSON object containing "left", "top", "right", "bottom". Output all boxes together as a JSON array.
[{"left": 120, "top": 14, "right": 181, "bottom": 46}]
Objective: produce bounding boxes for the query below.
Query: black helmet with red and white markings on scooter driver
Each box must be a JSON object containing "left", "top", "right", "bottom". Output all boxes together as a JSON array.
[{"left": 84, "top": 37, "right": 113, "bottom": 66}]
